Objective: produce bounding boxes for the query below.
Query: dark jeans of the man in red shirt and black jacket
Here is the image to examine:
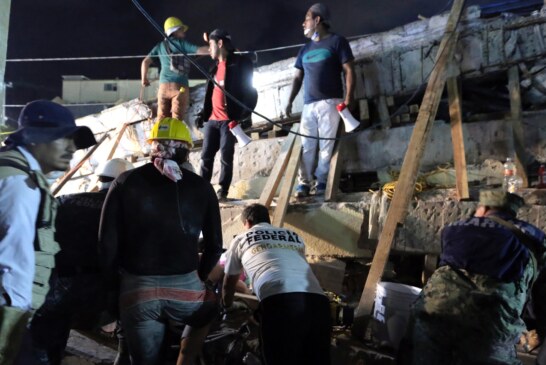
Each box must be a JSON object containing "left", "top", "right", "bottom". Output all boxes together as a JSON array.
[{"left": 199, "top": 120, "right": 237, "bottom": 194}]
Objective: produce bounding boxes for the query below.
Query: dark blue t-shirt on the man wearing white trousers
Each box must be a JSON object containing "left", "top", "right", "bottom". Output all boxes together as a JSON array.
[{"left": 295, "top": 33, "right": 354, "bottom": 104}]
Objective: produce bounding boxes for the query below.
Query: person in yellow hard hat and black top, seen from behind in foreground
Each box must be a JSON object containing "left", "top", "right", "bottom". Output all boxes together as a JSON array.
[{"left": 99, "top": 118, "right": 222, "bottom": 365}]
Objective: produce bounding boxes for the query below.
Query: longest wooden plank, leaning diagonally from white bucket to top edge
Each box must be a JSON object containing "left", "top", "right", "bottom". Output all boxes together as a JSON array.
[{"left": 353, "top": 0, "right": 465, "bottom": 337}]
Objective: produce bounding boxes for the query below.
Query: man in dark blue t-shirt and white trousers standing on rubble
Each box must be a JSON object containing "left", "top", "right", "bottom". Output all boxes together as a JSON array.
[{"left": 286, "top": 3, "right": 354, "bottom": 197}]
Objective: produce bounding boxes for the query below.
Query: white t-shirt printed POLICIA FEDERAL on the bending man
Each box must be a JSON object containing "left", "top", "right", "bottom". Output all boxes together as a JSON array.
[{"left": 224, "top": 223, "right": 324, "bottom": 300}]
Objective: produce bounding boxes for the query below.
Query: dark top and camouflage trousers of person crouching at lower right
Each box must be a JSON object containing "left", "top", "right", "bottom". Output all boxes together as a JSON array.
[{"left": 400, "top": 192, "right": 545, "bottom": 365}]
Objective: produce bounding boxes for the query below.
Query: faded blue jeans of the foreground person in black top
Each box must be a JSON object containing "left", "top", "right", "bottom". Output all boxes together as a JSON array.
[{"left": 120, "top": 271, "right": 218, "bottom": 365}]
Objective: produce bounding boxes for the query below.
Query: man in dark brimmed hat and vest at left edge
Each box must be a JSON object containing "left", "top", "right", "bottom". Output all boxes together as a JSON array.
[{"left": 0, "top": 100, "right": 96, "bottom": 364}]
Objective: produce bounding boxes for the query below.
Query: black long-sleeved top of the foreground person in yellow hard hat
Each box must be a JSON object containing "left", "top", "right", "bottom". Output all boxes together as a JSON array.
[{"left": 99, "top": 163, "right": 222, "bottom": 280}]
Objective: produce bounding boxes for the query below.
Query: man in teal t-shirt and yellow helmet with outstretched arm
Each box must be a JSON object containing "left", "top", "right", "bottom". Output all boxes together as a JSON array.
[{"left": 140, "top": 17, "right": 209, "bottom": 122}]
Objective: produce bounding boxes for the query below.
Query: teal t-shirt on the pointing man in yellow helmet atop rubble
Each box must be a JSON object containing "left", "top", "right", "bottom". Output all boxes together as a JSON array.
[{"left": 148, "top": 38, "right": 199, "bottom": 86}]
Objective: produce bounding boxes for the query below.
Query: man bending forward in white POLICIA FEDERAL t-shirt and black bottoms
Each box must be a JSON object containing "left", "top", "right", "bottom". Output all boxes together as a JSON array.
[{"left": 222, "top": 204, "right": 331, "bottom": 365}]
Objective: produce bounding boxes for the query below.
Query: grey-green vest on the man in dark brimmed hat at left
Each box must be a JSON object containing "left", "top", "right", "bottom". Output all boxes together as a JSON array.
[{"left": 0, "top": 150, "right": 60, "bottom": 309}]
